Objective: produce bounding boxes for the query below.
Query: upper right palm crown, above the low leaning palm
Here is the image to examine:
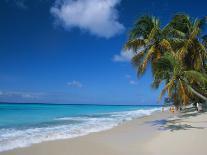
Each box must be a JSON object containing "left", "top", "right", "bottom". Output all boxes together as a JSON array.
[{"left": 167, "top": 14, "right": 207, "bottom": 72}]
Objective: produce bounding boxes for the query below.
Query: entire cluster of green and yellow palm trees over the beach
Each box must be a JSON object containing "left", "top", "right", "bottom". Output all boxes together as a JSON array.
[{"left": 125, "top": 13, "right": 207, "bottom": 106}]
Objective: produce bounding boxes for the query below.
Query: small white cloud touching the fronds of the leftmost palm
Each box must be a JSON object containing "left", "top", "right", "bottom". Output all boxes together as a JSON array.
[{"left": 113, "top": 50, "right": 135, "bottom": 62}]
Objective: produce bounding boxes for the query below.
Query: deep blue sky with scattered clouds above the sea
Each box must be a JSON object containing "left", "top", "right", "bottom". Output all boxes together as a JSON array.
[{"left": 0, "top": 0, "right": 207, "bottom": 104}]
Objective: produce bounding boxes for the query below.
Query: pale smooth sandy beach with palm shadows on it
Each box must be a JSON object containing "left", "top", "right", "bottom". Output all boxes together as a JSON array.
[{"left": 0, "top": 111, "right": 207, "bottom": 155}]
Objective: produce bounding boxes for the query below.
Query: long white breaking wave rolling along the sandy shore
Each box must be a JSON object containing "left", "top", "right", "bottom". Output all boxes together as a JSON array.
[{"left": 0, "top": 108, "right": 160, "bottom": 152}]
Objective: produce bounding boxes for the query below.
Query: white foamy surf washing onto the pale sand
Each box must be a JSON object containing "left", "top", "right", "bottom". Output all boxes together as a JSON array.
[{"left": 0, "top": 107, "right": 160, "bottom": 152}]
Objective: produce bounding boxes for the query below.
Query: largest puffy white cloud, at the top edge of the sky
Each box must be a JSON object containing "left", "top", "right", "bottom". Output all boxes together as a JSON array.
[{"left": 50, "top": 0, "right": 125, "bottom": 38}]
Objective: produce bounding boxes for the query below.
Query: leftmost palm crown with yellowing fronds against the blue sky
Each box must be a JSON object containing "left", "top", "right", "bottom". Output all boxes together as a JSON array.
[{"left": 125, "top": 16, "right": 166, "bottom": 75}]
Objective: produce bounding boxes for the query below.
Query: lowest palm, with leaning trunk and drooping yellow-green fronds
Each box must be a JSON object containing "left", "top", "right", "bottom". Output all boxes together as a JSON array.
[{"left": 154, "top": 52, "right": 207, "bottom": 105}]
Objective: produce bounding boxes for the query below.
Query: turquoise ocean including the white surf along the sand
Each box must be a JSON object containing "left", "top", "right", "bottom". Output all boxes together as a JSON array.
[{"left": 0, "top": 103, "right": 161, "bottom": 152}]
